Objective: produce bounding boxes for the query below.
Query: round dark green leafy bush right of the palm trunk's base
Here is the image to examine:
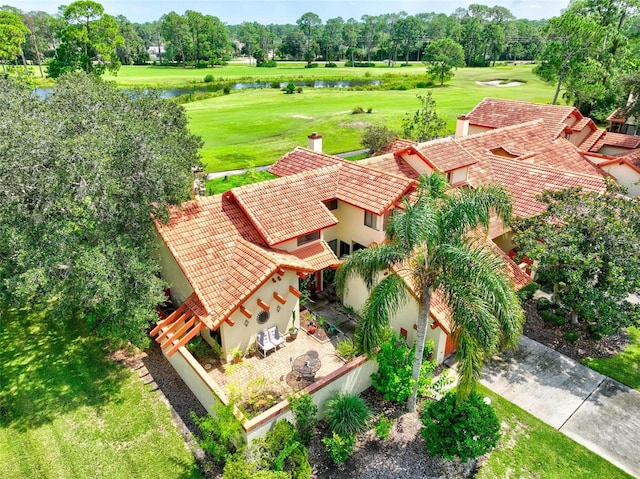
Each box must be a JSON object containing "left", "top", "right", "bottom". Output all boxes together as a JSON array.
[{"left": 420, "top": 392, "right": 500, "bottom": 462}]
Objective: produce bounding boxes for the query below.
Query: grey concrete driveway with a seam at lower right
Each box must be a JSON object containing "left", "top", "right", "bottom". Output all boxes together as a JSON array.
[{"left": 481, "top": 336, "right": 640, "bottom": 477}]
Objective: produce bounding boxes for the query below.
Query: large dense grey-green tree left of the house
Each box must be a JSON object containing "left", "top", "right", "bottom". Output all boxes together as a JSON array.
[{"left": 0, "top": 73, "right": 201, "bottom": 345}]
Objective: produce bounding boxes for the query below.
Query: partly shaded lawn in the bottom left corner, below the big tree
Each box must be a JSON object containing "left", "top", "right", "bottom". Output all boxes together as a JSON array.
[{"left": 0, "top": 311, "right": 201, "bottom": 479}]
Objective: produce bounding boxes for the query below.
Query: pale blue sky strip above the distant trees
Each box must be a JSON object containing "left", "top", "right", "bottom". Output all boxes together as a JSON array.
[{"left": 12, "top": 0, "right": 569, "bottom": 25}]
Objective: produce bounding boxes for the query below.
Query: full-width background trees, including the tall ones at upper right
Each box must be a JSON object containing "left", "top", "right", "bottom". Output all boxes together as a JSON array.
[{"left": 0, "top": 0, "right": 640, "bottom": 120}]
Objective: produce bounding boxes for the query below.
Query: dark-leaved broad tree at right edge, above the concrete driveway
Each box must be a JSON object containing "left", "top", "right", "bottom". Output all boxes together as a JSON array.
[{"left": 513, "top": 182, "right": 640, "bottom": 334}]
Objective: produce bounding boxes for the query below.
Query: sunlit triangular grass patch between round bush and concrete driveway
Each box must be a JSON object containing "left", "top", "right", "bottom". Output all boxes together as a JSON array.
[{"left": 476, "top": 385, "right": 632, "bottom": 479}]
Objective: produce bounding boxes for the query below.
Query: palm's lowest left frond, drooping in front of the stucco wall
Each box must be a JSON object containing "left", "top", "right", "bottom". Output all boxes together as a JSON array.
[{"left": 356, "top": 273, "right": 409, "bottom": 356}]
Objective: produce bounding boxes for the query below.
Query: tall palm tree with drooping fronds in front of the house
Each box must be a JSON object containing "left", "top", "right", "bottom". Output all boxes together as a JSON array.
[{"left": 336, "top": 173, "right": 524, "bottom": 411}]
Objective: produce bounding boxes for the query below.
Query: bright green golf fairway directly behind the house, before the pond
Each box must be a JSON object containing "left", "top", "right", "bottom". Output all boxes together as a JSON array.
[{"left": 185, "top": 66, "right": 552, "bottom": 172}]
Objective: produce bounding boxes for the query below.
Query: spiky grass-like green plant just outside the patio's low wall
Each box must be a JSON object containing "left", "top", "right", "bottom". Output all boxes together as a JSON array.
[{"left": 324, "top": 391, "right": 371, "bottom": 436}]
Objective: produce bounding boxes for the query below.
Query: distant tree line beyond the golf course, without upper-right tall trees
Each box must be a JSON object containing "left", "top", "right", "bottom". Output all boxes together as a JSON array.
[{"left": 0, "top": 1, "right": 546, "bottom": 73}]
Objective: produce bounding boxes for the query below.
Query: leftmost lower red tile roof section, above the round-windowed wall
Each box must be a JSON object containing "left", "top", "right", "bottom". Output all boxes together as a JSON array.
[{"left": 157, "top": 195, "right": 315, "bottom": 329}]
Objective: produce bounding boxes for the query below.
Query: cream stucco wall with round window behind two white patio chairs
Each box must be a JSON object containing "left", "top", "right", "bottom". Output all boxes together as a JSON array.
[{"left": 220, "top": 270, "right": 300, "bottom": 360}]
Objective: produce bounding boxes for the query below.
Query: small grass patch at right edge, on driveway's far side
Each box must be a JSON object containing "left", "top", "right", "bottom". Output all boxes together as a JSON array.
[{"left": 582, "top": 328, "right": 640, "bottom": 391}]
